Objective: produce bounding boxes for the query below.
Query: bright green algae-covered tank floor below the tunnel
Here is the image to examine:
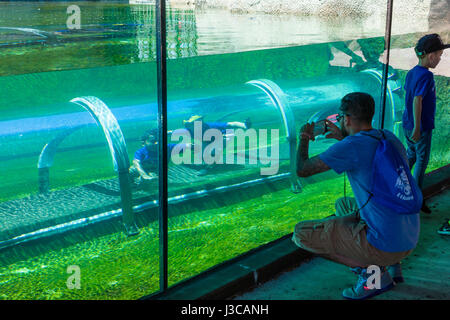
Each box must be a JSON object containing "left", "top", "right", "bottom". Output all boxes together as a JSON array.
[{"left": 0, "top": 174, "right": 352, "bottom": 299}]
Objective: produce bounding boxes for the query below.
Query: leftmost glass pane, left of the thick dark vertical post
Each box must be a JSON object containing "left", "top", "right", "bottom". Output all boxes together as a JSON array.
[{"left": 0, "top": 2, "right": 159, "bottom": 299}]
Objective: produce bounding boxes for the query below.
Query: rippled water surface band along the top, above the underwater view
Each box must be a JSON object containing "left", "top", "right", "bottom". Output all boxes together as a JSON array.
[{"left": 0, "top": 1, "right": 390, "bottom": 76}]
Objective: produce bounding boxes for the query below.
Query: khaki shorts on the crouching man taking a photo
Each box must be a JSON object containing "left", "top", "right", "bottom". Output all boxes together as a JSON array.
[{"left": 292, "top": 197, "right": 412, "bottom": 268}]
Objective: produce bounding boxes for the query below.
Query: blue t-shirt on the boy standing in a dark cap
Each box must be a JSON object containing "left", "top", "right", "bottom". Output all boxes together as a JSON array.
[{"left": 402, "top": 65, "right": 436, "bottom": 132}]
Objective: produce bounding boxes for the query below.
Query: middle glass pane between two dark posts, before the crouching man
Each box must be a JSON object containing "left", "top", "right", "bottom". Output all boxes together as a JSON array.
[{"left": 167, "top": 1, "right": 390, "bottom": 285}]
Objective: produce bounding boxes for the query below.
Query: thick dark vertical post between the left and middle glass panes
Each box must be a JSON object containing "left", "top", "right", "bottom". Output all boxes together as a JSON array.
[{"left": 156, "top": 0, "right": 168, "bottom": 291}]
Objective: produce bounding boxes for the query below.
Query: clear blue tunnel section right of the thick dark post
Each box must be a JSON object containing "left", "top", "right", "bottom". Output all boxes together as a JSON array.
[{"left": 163, "top": 69, "right": 401, "bottom": 193}]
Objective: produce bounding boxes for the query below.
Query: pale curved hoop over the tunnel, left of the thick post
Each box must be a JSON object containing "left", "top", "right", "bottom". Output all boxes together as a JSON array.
[{"left": 70, "top": 96, "right": 139, "bottom": 236}]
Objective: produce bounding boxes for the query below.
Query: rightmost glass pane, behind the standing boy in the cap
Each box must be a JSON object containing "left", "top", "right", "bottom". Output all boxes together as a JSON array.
[{"left": 390, "top": 0, "right": 450, "bottom": 173}]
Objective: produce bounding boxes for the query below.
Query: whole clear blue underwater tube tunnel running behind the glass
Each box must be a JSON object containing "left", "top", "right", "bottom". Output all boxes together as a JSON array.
[{"left": 0, "top": 65, "right": 401, "bottom": 245}]
